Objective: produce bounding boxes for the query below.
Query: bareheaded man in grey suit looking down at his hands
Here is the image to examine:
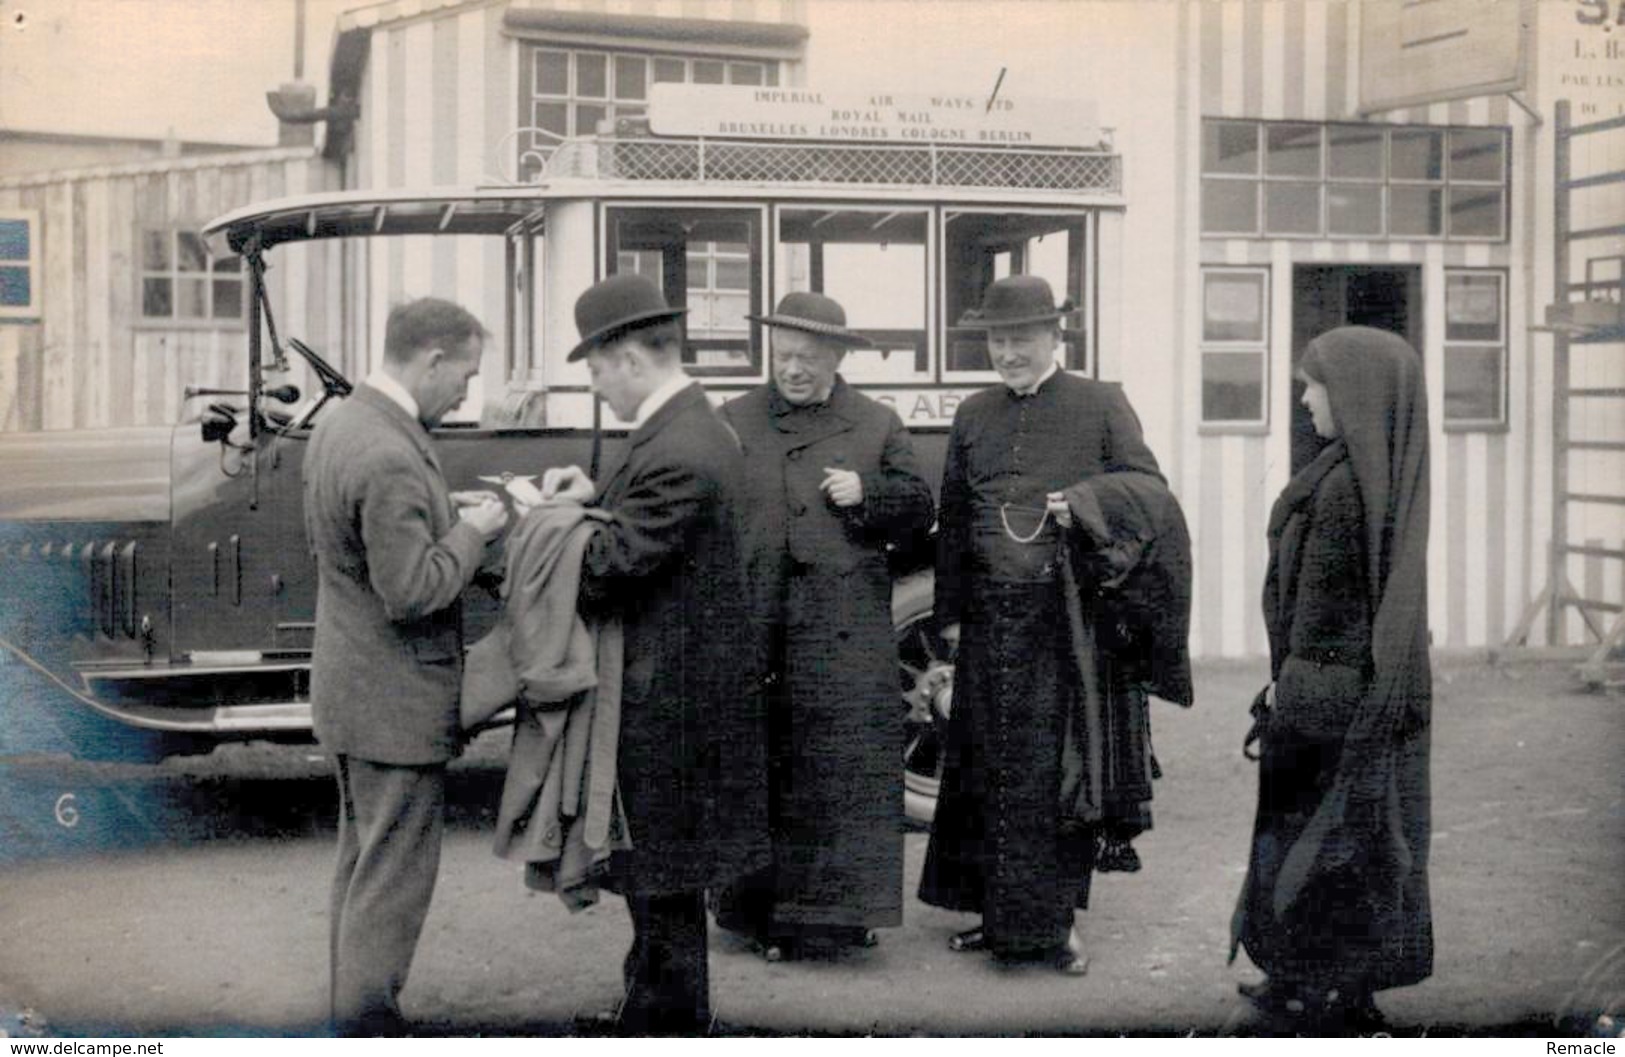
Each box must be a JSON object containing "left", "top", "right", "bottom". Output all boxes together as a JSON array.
[{"left": 304, "top": 298, "right": 507, "bottom": 1034}]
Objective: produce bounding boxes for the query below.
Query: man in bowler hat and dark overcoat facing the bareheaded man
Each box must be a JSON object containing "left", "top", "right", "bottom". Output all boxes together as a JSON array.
[{"left": 523, "top": 275, "right": 767, "bottom": 1034}]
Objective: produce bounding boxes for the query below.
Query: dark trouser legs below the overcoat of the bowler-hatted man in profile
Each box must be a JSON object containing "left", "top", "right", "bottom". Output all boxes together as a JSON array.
[{"left": 619, "top": 891, "right": 710, "bottom": 1034}]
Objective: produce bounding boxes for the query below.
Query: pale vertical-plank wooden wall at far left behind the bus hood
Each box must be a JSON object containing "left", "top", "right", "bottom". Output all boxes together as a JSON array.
[{"left": 0, "top": 148, "right": 341, "bottom": 431}]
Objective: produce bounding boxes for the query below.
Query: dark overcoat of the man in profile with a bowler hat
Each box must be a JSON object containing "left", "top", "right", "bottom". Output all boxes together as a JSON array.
[{"left": 579, "top": 384, "right": 767, "bottom": 894}]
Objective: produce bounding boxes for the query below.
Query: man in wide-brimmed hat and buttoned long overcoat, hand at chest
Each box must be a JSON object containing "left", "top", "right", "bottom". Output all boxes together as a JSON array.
[{"left": 717, "top": 293, "right": 933, "bottom": 961}]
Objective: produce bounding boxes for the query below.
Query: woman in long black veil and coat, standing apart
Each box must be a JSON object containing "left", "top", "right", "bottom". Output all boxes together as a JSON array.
[{"left": 1230, "top": 327, "right": 1433, "bottom": 1028}]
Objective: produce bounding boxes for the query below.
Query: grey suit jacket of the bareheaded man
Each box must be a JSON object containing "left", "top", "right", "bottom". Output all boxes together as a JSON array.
[{"left": 304, "top": 385, "right": 484, "bottom": 764}]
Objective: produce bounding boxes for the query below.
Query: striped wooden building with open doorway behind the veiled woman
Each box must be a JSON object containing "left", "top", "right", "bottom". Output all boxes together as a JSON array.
[{"left": 1176, "top": 0, "right": 1625, "bottom": 655}]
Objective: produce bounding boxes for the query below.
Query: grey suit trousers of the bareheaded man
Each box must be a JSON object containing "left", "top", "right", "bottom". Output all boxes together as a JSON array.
[{"left": 328, "top": 755, "right": 445, "bottom": 1034}]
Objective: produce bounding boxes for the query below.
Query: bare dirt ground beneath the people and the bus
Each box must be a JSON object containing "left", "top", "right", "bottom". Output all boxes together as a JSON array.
[{"left": 0, "top": 662, "right": 1625, "bottom": 1036}]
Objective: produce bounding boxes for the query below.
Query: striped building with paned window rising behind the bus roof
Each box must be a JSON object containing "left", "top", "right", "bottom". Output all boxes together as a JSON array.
[{"left": 315, "top": 0, "right": 808, "bottom": 415}]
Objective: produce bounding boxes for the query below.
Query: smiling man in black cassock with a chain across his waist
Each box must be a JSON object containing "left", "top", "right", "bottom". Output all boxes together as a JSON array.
[{"left": 920, "top": 275, "right": 1162, "bottom": 976}]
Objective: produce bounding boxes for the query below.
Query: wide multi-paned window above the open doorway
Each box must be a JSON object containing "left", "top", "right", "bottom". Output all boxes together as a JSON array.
[{"left": 1203, "top": 119, "right": 1511, "bottom": 241}]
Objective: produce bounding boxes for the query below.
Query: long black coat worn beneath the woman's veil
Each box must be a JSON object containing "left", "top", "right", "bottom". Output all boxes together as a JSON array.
[{"left": 1235, "top": 446, "right": 1432, "bottom": 990}]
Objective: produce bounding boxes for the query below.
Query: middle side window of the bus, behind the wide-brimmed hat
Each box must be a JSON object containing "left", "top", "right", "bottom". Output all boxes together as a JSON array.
[{"left": 774, "top": 207, "right": 931, "bottom": 384}]
